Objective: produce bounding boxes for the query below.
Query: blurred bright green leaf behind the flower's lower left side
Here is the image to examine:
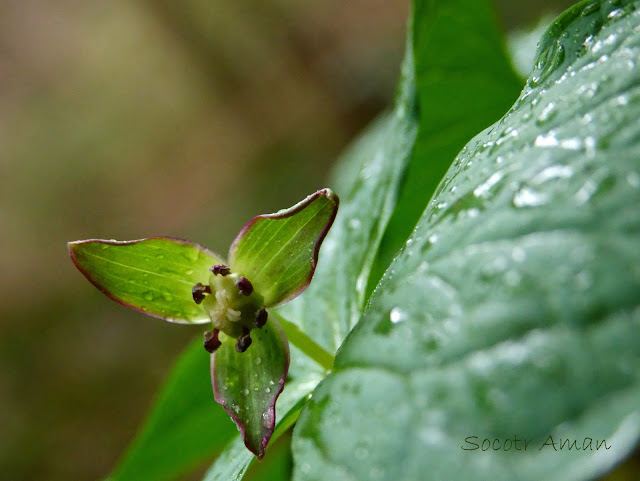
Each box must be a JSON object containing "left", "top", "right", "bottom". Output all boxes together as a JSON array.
[{"left": 109, "top": 339, "right": 237, "bottom": 481}]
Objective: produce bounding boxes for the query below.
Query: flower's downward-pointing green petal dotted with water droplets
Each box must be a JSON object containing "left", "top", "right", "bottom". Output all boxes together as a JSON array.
[{"left": 211, "top": 317, "right": 289, "bottom": 458}]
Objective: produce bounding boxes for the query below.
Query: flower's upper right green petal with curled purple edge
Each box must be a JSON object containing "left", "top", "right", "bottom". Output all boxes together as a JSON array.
[{"left": 229, "top": 189, "right": 338, "bottom": 307}]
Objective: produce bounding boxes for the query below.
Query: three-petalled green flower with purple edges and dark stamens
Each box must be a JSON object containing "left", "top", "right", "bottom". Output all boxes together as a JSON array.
[{"left": 68, "top": 189, "right": 338, "bottom": 458}]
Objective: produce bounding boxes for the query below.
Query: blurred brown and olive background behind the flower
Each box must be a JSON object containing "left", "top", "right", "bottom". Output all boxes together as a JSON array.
[{"left": 0, "top": 0, "right": 572, "bottom": 481}]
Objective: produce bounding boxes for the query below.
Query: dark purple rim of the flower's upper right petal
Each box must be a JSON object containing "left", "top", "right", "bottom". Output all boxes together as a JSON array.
[{"left": 227, "top": 188, "right": 340, "bottom": 307}]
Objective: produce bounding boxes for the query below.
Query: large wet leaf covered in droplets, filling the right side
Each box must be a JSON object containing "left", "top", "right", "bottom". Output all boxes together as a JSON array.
[{"left": 293, "top": 0, "right": 640, "bottom": 481}]
